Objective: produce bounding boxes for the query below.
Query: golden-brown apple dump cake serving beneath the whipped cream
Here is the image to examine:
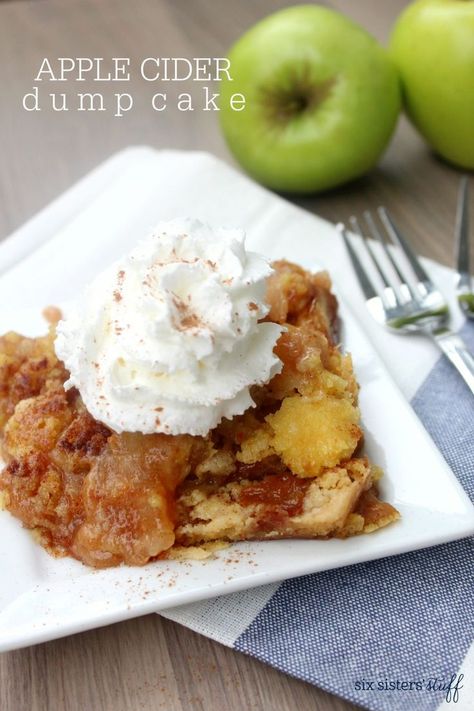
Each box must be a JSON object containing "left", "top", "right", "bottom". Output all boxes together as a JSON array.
[{"left": 0, "top": 220, "right": 399, "bottom": 567}]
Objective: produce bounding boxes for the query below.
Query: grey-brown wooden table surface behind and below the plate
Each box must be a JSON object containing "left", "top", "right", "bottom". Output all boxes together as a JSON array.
[{"left": 0, "top": 0, "right": 466, "bottom": 711}]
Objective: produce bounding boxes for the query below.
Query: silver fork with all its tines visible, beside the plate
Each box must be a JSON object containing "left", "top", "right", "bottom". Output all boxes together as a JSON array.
[{"left": 338, "top": 207, "right": 474, "bottom": 394}]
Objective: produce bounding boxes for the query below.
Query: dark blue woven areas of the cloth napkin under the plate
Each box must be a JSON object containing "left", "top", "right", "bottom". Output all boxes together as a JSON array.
[{"left": 234, "top": 324, "right": 474, "bottom": 711}]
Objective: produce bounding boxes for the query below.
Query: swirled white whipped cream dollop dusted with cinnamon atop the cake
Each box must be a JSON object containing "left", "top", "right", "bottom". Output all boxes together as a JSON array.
[{"left": 55, "top": 219, "right": 283, "bottom": 435}]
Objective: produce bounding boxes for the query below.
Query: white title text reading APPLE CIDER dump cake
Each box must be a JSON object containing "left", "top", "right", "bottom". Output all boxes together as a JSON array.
[{"left": 22, "top": 57, "right": 245, "bottom": 118}]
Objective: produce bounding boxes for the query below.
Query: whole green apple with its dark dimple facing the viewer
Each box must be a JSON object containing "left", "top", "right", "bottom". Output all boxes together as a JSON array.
[{"left": 220, "top": 5, "right": 401, "bottom": 193}]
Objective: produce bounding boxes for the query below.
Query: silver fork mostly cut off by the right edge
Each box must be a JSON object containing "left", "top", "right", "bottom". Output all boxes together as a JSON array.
[{"left": 456, "top": 175, "right": 474, "bottom": 318}]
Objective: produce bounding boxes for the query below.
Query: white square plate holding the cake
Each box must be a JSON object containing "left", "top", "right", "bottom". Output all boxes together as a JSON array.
[{"left": 0, "top": 149, "right": 474, "bottom": 651}]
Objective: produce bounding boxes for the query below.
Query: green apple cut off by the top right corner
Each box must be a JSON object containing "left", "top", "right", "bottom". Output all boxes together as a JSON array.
[{"left": 391, "top": 0, "right": 474, "bottom": 168}]
